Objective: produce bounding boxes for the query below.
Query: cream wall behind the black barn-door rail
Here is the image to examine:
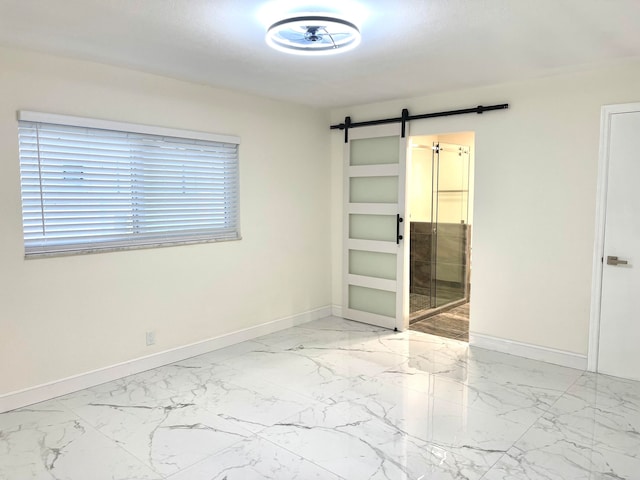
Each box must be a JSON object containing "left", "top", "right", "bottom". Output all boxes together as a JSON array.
[{"left": 331, "top": 62, "right": 640, "bottom": 354}]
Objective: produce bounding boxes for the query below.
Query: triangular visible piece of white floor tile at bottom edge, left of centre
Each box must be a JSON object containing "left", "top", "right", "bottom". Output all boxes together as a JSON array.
[{"left": 168, "top": 437, "right": 342, "bottom": 480}]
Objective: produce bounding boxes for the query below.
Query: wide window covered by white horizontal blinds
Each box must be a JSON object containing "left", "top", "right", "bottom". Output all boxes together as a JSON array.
[{"left": 18, "top": 112, "right": 240, "bottom": 256}]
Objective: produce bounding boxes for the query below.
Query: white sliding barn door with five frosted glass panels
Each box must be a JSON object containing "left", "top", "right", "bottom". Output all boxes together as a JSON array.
[{"left": 342, "top": 124, "right": 409, "bottom": 330}]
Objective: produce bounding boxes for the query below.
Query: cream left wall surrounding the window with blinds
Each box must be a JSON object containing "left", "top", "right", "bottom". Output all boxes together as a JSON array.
[{"left": 0, "top": 49, "right": 331, "bottom": 394}]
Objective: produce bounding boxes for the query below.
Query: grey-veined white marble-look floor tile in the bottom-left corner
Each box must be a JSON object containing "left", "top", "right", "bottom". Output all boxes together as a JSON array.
[{"left": 0, "top": 402, "right": 162, "bottom": 480}]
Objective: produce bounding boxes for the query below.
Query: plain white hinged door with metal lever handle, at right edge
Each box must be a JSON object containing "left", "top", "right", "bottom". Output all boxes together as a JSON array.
[{"left": 597, "top": 104, "right": 640, "bottom": 380}]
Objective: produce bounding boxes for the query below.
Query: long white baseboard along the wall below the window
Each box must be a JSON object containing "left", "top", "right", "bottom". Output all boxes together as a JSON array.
[{"left": 0, "top": 306, "right": 332, "bottom": 413}]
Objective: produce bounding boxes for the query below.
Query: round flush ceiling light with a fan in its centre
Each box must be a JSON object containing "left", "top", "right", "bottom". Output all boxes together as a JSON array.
[{"left": 267, "top": 15, "right": 360, "bottom": 55}]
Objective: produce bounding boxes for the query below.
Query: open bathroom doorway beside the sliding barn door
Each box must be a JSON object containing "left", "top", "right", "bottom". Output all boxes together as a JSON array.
[{"left": 407, "top": 132, "right": 475, "bottom": 342}]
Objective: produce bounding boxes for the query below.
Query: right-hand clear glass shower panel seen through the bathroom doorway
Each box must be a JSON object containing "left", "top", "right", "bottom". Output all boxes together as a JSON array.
[{"left": 430, "top": 143, "right": 469, "bottom": 308}]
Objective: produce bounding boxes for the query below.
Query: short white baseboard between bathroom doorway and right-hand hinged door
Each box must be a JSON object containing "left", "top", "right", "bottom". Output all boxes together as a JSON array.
[{"left": 469, "top": 332, "right": 587, "bottom": 370}]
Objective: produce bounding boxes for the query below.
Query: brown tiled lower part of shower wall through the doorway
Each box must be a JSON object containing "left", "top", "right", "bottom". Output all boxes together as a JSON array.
[{"left": 410, "top": 222, "right": 471, "bottom": 295}]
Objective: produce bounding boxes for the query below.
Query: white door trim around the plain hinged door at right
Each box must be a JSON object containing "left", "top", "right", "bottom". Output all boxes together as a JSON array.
[{"left": 587, "top": 102, "right": 640, "bottom": 372}]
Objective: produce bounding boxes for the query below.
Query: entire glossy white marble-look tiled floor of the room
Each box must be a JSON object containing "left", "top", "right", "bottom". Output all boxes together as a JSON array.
[{"left": 5, "top": 317, "right": 640, "bottom": 480}]
